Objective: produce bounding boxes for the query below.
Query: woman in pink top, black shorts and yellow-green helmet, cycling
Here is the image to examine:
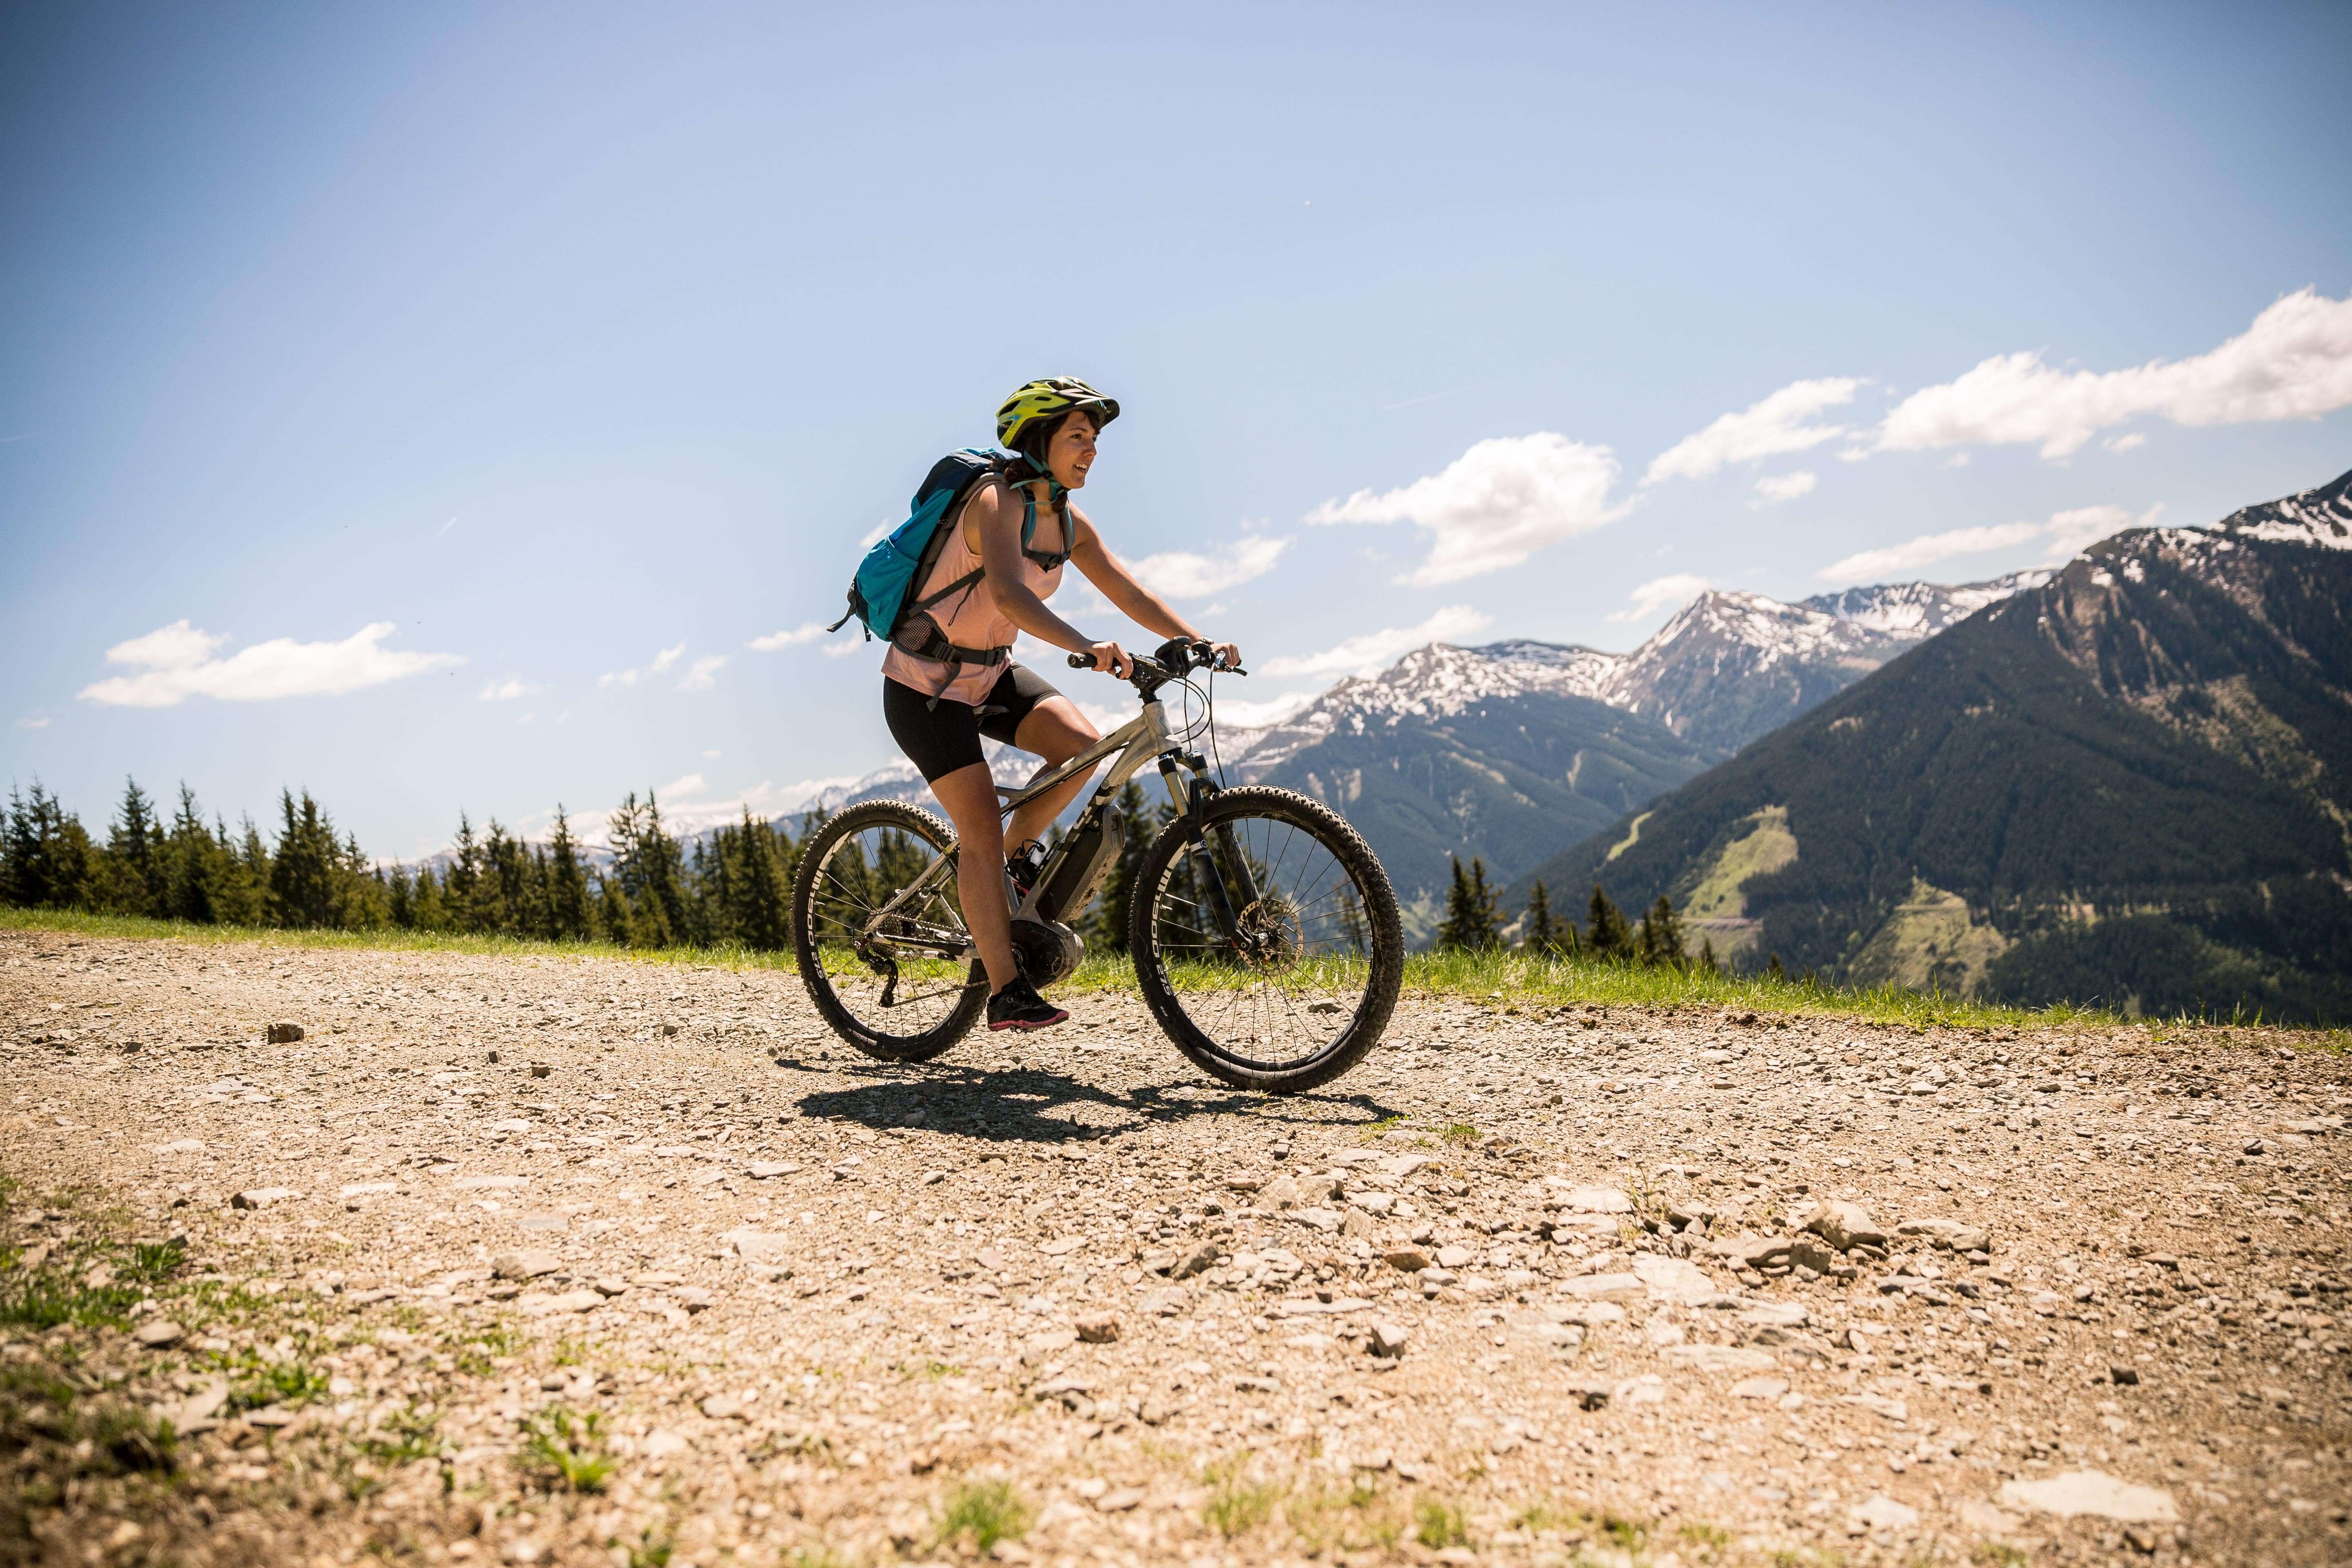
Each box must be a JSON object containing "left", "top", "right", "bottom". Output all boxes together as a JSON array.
[{"left": 882, "top": 376, "right": 1242, "bottom": 1030}]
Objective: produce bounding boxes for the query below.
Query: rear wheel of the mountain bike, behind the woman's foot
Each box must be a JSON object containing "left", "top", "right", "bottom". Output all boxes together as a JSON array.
[{"left": 793, "top": 799, "right": 988, "bottom": 1062}]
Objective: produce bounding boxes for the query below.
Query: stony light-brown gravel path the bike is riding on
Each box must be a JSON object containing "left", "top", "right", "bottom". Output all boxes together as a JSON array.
[{"left": 0, "top": 933, "right": 2352, "bottom": 1568}]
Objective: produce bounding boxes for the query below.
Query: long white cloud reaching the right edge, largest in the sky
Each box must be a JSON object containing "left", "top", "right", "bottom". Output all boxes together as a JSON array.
[{"left": 1877, "top": 289, "right": 2352, "bottom": 459}]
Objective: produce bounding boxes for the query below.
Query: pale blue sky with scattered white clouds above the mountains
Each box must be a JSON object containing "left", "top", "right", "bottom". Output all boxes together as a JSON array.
[{"left": 0, "top": 5, "right": 2352, "bottom": 856}]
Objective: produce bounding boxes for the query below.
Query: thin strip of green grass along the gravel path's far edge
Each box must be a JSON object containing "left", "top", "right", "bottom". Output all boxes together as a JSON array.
[{"left": 13, "top": 907, "right": 2352, "bottom": 1049}]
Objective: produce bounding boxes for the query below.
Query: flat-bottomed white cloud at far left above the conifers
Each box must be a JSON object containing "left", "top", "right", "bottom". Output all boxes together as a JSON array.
[{"left": 78, "top": 621, "right": 466, "bottom": 708}]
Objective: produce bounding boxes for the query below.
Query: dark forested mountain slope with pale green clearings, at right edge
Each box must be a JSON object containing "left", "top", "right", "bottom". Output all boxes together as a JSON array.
[{"left": 1512, "top": 475, "right": 2352, "bottom": 1018}]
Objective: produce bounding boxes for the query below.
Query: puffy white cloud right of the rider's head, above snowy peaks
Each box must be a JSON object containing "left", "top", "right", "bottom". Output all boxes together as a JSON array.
[{"left": 1305, "top": 430, "right": 1628, "bottom": 588}]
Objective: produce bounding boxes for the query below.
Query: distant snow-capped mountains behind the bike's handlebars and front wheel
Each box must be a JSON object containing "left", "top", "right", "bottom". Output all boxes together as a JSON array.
[{"left": 821, "top": 571, "right": 2051, "bottom": 940}]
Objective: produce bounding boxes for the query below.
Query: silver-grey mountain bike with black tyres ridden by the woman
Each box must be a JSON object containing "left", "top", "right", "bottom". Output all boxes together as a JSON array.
[{"left": 793, "top": 637, "right": 1404, "bottom": 1091}]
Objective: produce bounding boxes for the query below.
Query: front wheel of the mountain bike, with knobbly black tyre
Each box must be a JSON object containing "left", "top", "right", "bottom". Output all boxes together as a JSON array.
[{"left": 1129, "top": 785, "right": 1404, "bottom": 1093}]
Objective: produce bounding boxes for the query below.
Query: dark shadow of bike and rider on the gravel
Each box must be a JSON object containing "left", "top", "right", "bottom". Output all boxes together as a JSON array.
[{"left": 779, "top": 1058, "right": 1402, "bottom": 1143}]
